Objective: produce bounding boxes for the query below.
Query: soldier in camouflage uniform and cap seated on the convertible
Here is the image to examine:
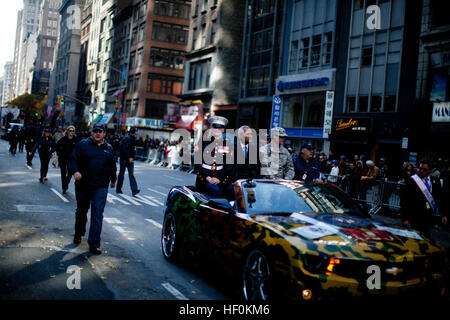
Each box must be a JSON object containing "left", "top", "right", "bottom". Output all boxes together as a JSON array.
[{"left": 260, "top": 127, "right": 295, "bottom": 180}]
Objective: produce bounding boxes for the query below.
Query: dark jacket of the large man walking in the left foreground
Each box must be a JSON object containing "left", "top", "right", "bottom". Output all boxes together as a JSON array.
[{"left": 68, "top": 137, "right": 117, "bottom": 188}]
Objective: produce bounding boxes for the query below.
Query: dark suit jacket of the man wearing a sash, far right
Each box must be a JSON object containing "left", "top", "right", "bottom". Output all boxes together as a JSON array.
[{"left": 400, "top": 177, "right": 447, "bottom": 233}]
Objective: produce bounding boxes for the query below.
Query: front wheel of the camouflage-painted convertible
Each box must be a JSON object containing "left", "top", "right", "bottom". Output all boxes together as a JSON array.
[{"left": 242, "top": 250, "right": 272, "bottom": 301}]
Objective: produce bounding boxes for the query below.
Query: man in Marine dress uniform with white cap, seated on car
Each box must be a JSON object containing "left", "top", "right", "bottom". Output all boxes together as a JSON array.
[{"left": 194, "top": 116, "right": 233, "bottom": 200}]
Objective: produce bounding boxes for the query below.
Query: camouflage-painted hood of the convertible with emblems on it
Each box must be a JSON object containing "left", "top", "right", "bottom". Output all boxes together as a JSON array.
[{"left": 249, "top": 212, "right": 444, "bottom": 261}]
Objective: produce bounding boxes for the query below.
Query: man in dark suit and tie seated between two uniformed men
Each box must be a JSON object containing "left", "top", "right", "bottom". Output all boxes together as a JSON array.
[{"left": 233, "top": 126, "right": 261, "bottom": 181}]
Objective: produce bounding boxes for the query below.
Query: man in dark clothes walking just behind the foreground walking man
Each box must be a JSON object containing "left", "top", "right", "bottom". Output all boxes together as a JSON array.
[{"left": 116, "top": 128, "right": 140, "bottom": 196}]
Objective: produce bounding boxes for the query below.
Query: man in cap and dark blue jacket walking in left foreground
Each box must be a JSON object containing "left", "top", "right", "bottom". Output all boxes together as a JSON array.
[{"left": 69, "top": 125, "right": 117, "bottom": 254}]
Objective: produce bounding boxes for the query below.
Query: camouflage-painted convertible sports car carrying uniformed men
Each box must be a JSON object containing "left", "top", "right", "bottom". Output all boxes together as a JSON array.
[{"left": 161, "top": 180, "right": 447, "bottom": 300}]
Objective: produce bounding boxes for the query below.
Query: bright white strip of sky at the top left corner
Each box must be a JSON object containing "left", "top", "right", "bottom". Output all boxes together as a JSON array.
[{"left": 0, "top": 0, "right": 23, "bottom": 76}]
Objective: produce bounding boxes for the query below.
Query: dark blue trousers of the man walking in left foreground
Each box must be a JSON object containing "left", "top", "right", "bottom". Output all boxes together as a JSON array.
[{"left": 75, "top": 183, "right": 108, "bottom": 248}]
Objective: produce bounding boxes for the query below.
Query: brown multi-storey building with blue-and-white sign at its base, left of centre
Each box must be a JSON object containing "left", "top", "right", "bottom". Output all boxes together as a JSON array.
[{"left": 123, "top": 0, "right": 191, "bottom": 137}]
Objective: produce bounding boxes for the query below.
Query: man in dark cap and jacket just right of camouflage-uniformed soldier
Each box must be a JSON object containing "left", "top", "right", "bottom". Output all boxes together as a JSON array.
[{"left": 295, "top": 143, "right": 320, "bottom": 183}]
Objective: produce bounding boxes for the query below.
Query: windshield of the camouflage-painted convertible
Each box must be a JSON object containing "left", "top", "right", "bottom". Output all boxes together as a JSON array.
[{"left": 242, "top": 181, "right": 366, "bottom": 217}]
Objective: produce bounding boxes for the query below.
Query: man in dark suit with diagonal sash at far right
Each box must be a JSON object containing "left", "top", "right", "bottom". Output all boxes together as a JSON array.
[{"left": 401, "top": 160, "right": 448, "bottom": 236}]
